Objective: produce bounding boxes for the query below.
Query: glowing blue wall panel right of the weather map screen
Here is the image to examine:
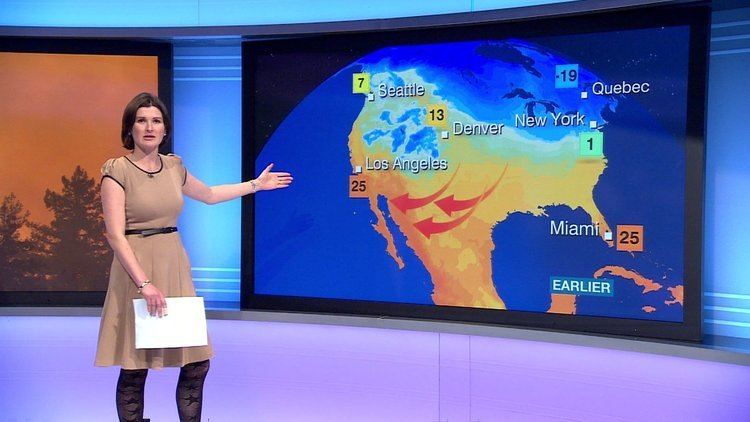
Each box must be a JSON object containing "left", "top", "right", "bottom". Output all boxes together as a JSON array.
[{"left": 703, "top": 8, "right": 750, "bottom": 338}]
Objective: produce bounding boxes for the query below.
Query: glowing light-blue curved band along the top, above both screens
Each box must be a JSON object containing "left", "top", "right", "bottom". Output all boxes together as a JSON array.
[{"left": 0, "top": 0, "right": 572, "bottom": 28}]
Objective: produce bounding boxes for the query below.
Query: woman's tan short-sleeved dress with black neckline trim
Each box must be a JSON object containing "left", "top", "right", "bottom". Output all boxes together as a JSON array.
[{"left": 94, "top": 154, "right": 213, "bottom": 369}]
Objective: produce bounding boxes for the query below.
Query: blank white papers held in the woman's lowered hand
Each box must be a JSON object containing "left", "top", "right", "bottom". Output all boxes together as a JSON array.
[{"left": 133, "top": 297, "right": 208, "bottom": 349}]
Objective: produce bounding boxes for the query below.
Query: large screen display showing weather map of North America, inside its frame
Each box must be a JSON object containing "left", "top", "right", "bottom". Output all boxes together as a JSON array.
[{"left": 249, "top": 10, "right": 704, "bottom": 340}]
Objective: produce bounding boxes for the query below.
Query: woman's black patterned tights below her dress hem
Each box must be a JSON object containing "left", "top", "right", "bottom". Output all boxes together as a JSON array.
[{"left": 115, "top": 360, "right": 210, "bottom": 422}]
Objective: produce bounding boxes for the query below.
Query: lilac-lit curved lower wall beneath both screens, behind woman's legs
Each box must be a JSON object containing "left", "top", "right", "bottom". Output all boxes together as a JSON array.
[{"left": 0, "top": 309, "right": 750, "bottom": 422}]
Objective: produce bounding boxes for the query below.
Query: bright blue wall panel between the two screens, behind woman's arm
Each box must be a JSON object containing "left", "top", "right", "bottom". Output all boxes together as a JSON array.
[{"left": 174, "top": 44, "right": 242, "bottom": 309}]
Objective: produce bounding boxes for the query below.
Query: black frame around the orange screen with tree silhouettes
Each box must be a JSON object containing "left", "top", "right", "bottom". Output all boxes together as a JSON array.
[{"left": 0, "top": 36, "right": 174, "bottom": 307}]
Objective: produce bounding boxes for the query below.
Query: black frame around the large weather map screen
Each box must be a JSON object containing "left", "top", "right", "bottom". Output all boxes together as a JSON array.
[{"left": 241, "top": 3, "right": 711, "bottom": 341}]
